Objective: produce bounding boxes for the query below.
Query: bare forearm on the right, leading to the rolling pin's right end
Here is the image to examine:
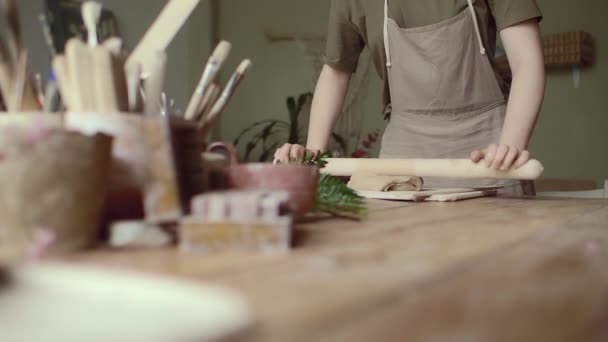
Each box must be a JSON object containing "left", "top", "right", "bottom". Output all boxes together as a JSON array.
[{"left": 499, "top": 23, "right": 546, "bottom": 150}]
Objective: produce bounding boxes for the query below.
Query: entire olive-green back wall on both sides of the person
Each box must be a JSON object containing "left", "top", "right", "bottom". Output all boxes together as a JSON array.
[{"left": 220, "top": 0, "right": 608, "bottom": 184}]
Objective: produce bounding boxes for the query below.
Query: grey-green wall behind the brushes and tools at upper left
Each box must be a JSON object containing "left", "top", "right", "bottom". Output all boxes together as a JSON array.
[{"left": 19, "top": 0, "right": 210, "bottom": 107}]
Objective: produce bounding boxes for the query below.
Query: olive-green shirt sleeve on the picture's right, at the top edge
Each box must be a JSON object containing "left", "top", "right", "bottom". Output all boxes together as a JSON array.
[{"left": 488, "top": 0, "right": 542, "bottom": 31}]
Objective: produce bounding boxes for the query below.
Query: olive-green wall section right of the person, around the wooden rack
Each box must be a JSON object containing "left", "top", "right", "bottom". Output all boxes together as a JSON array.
[{"left": 531, "top": 0, "right": 608, "bottom": 184}]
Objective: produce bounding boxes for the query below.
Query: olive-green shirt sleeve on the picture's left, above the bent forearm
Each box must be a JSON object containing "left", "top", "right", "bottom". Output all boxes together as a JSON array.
[{"left": 324, "top": 0, "right": 365, "bottom": 72}]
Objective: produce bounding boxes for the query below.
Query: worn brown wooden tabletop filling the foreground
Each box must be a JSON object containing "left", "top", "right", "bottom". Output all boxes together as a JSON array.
[{"left": 64, "top": 198, "right": 608, "bottom": 342}]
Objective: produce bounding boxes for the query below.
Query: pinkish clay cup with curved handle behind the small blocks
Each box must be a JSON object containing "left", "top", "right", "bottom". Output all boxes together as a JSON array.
[{"left": 207, "top": 142, "right": 320, "bottom": 218}]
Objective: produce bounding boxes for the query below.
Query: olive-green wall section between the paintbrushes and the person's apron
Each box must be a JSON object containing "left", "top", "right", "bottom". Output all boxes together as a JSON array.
[{"left": 220, "top": 0, "right": 382, "bottom": 152}]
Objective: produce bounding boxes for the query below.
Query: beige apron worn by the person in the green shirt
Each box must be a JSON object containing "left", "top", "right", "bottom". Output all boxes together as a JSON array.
[{"left": 380, "top": 0, "right": 523, "bottom": 195}]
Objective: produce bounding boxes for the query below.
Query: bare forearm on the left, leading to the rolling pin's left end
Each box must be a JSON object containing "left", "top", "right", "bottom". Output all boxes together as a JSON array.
[{"left": 306, "top": 65, "right": 352, "bottom": 150}]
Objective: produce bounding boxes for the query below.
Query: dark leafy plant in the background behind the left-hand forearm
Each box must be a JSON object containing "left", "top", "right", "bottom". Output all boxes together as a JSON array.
[{"left": 233, "top": 92, "right": 347, "bottom": 162}]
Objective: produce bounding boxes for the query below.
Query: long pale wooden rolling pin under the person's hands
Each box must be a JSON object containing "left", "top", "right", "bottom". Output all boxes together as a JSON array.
[{"left": 321, "top": 158, "right": 544, "bottom": 180}]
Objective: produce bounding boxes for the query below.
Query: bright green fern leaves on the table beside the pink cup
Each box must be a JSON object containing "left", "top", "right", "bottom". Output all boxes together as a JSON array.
[{"left": 290, "top": 152, "right": 367, "bottom": 217}]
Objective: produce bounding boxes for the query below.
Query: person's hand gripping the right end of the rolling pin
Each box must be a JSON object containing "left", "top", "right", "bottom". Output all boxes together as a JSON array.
[{"left": 471, "top": 144, "right": 530, "bottom": 171}]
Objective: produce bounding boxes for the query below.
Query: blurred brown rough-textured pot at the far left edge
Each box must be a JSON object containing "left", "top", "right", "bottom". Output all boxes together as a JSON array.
[{"left": 0, "top": 130, "right": 112, "bottom": 262}]
